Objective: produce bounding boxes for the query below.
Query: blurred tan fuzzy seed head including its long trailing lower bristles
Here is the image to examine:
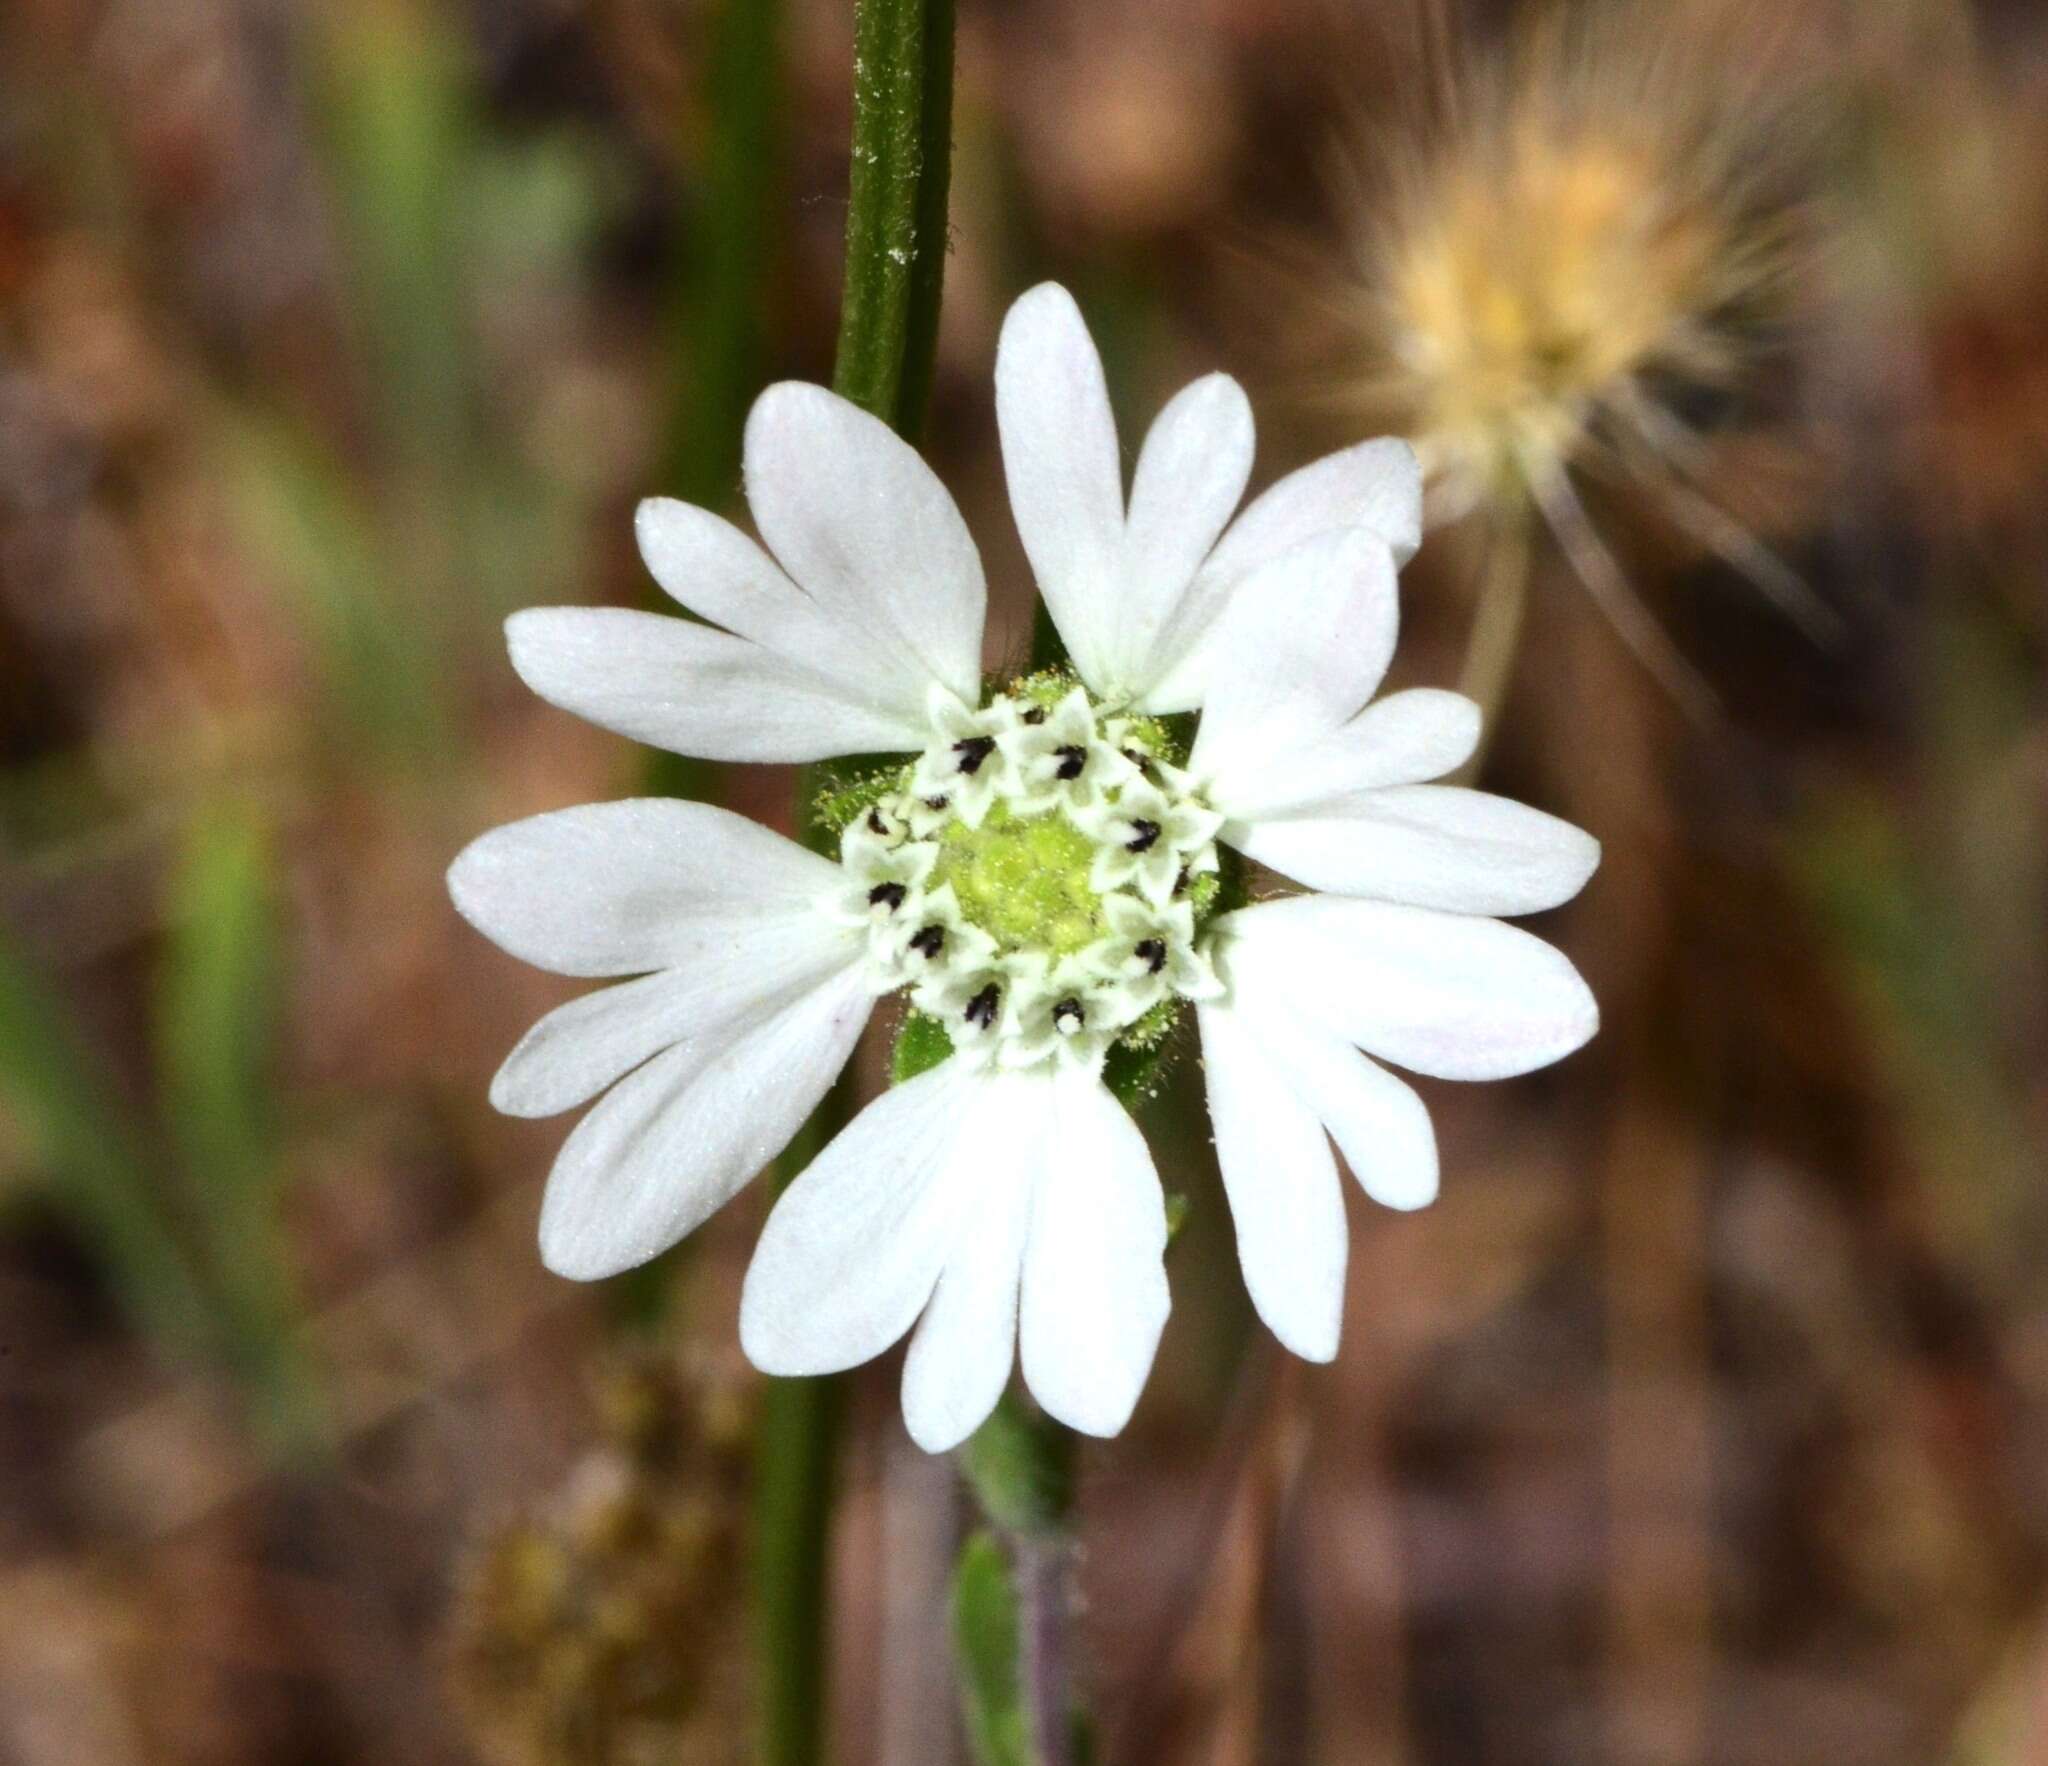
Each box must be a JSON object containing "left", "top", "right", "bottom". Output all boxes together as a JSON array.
[{"left": 1337, "top": 4, "right": 1833, "bottom": 709}]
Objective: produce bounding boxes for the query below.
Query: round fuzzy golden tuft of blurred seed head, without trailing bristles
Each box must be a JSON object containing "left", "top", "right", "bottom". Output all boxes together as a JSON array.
[{"left": 1343, "top": 8, "right": 1788, "bottom": 518}]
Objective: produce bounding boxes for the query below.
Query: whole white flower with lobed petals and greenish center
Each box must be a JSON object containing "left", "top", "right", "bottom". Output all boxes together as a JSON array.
[{"left": 449, "top": 287, "right": 1597, "bottom": 1450}]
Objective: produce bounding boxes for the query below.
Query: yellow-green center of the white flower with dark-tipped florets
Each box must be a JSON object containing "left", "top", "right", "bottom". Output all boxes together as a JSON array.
[{"left": 823, "top": 676, "right": 1221, "bottom": 1067}]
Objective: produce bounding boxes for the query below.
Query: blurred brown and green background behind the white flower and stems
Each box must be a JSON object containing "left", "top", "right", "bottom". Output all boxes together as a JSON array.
[{"left": 0, "top": 0, "right": 2048, "bottom": 1766}]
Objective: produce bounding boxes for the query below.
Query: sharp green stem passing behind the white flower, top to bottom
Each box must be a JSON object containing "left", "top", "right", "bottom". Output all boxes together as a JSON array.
[{"left": 754, "top": 0, "right": 952, "bottom": 1766}]
